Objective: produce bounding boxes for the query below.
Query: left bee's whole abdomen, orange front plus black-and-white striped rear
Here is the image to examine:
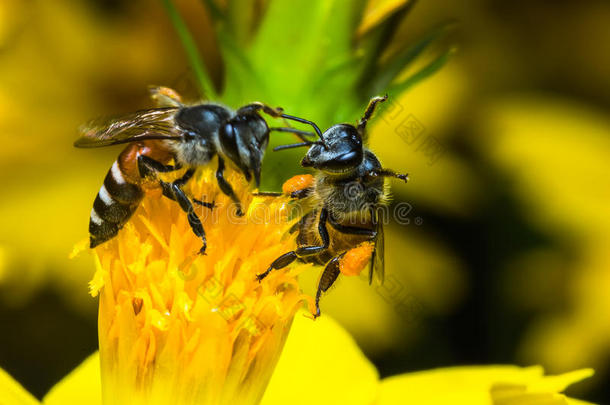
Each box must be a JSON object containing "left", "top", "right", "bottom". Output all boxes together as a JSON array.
[{"left": 89, "top": 144, "right": 167, "bottom": 248}]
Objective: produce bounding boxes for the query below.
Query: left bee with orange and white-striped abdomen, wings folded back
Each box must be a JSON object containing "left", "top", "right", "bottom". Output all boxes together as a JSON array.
[{"left": 74, "top": 87, "right": 312, "bottom": 254}]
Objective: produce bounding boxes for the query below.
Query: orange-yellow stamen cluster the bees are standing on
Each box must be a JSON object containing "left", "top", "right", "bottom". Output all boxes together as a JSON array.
[{"left": 91, "top": 165, "right": 307, "bottom": 404}]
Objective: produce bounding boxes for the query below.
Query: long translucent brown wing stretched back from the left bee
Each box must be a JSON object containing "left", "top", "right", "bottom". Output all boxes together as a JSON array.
[{"left": 74, "top": 107, "right": 184, "bottom": 148}]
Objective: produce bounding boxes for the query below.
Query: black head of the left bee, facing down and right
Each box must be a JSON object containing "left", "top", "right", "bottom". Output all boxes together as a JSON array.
[{"left": 219, "top": 114, "right": 269, "bottom": 186}]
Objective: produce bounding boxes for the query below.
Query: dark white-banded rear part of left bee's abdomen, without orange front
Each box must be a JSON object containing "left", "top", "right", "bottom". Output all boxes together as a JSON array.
[{"left": 89, "top": 161, "right": 144, "bottom": 248}]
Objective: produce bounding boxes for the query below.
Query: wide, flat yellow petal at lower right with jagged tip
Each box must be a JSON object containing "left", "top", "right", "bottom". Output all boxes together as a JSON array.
[{"left": 377, "top": 366, "right": 592, "bottom": 405}]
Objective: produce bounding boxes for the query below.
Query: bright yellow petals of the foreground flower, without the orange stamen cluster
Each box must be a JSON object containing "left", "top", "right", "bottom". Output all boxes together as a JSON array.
[{"left": 0, "top": 314, "right": 593, "bottom": 405}]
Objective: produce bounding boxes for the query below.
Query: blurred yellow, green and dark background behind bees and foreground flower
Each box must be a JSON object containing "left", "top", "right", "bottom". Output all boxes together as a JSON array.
[{"left": 0, "top": 0, "right": 610, "bottom": 403}]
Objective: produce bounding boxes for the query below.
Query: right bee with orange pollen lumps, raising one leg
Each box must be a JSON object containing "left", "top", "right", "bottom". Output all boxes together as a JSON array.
[{"left": 257, "top": 96, "right": 408, "bottom": 317}]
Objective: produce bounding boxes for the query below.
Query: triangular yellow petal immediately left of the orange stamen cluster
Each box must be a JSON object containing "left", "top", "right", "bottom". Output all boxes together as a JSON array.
[{"left": 42, "top": 353, "right": 102, "bottom": 405}]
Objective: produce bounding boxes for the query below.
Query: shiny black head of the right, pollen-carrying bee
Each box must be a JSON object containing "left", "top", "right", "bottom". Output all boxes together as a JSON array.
[{"left": 301, "top": 124, "right": 363, "bottom": 174}]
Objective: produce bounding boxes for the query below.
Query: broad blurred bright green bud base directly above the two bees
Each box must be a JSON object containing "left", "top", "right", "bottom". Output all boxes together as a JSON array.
[{"left": 243, "top": 0, "right": 359, "bottom": 123}]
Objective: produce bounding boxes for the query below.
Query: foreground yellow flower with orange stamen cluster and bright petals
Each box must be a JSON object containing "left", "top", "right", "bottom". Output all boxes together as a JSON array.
[{"left": 0, "top": 165, "right": 592, "bottom": 405}]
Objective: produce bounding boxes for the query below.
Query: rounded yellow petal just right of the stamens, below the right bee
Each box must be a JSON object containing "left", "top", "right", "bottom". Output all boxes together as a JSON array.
[{"left": 262, "top": 312, "right": 378, "bottom": 405}]
